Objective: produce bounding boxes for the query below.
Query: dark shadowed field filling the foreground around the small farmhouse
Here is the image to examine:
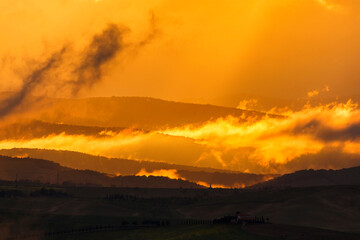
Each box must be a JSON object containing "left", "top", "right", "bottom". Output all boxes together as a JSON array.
[{"left": 0, "top": 182, "right": 360, "bottom": 239}]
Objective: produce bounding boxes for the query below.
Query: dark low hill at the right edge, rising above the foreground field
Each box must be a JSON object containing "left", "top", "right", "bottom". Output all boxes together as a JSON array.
[{"left": 252, "top": 167, "right": 360, "bottom": 188}]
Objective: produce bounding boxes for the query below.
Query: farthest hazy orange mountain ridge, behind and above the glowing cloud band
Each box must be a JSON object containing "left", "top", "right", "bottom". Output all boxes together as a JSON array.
[{"left": 31, "top": 97, "right": 280, "bottom": 130}]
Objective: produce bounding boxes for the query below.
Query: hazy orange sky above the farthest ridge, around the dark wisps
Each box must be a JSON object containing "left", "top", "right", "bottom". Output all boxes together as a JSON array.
[{"left": 0, "top": 0, "right": 360, "bottom": 102}]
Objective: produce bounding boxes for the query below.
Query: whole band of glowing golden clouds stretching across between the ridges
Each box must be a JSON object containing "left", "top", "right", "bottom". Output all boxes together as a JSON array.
[{"left": 0, "top": 101, "right": 360, "bottom": 173}]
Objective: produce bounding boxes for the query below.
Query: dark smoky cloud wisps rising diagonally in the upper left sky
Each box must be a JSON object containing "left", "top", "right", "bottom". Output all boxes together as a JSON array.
[{"left": 0, "top": 17, "right": 158, "bottom": 118}]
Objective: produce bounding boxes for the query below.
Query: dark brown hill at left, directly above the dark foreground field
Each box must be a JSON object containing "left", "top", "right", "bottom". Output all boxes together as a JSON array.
[{"left": 0, "top": 156, "right": 202, "bottom": 188}]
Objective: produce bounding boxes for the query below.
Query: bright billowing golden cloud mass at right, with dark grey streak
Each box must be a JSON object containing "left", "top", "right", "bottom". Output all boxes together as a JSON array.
[{"left": 163, "top": 101, "right": 360, "bottom": 172}]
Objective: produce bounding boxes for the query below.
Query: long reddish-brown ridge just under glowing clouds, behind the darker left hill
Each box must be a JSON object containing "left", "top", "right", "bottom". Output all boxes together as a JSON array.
[{"left": 0, "top": 148, "right": 278, "bottom": 187}]
